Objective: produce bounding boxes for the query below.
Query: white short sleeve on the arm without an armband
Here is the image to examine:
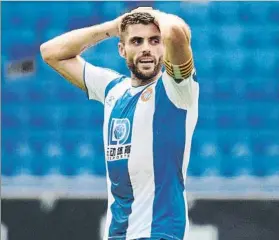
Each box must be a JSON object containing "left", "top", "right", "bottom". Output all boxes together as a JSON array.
[{"left": 83, "top": 62, "right": 121, "bottom": 103}]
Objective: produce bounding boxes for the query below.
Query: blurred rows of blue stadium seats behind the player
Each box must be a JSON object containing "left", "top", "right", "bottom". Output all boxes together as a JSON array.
[{"left": 1, "top": 1, "right": 279, "bottom": 196}]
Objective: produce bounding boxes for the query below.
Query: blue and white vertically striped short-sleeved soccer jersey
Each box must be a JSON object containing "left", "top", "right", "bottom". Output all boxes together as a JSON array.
[{"left": 84, "top": 63, "right": 199, "bottom": 240}]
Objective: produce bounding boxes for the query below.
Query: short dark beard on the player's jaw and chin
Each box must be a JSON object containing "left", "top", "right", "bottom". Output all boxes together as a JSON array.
[{"left": 126, "top": 57, "right": 163, "bottom": 82}]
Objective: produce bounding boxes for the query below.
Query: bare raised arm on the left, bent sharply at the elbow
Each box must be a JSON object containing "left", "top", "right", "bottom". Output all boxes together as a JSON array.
[{"left": 40, "top": 17, "right": 121, "bottom": 91}]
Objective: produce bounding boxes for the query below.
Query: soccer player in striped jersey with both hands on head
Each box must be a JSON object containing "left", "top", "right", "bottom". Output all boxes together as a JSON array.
[{"left": 41, "top": 8, "right": 199, "bottom": 240}]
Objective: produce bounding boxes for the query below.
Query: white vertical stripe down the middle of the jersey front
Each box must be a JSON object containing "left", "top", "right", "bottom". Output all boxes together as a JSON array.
[{"left": 127, "top": 84, "right": 158, "bottom": 239}]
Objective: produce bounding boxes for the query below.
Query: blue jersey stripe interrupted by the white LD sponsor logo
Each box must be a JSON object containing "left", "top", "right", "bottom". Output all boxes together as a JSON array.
[{"left": 107, "top": 87, "right": 143, "bottom": 237}]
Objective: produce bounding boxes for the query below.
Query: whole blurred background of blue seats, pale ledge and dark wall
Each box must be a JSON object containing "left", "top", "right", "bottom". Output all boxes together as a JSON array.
[{"left": 1, "top": 1, "right": 279, "bottom": 240}]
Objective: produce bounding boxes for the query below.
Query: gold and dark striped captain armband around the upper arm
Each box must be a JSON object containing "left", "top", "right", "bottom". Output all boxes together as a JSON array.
[{"left": 164, "top": 58, "right": 194, "bottom": 80}]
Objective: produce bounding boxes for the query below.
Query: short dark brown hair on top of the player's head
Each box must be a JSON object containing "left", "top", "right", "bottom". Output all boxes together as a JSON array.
[{"left": 120, "top": 12, "right": 156, "bottom": 33}]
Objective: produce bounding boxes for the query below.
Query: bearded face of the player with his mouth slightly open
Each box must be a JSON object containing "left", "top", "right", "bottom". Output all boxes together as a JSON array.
[{"left": 120, "top": 24, "right": 164, "bottom": 81}]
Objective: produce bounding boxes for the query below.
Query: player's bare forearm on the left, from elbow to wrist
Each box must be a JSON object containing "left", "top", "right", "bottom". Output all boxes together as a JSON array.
[{"left": 40, "top": 21, "right": 118, "bottom": 61}]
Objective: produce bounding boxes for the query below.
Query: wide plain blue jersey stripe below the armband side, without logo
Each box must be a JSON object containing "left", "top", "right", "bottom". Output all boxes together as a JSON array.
[{"left": 151, "top": 80, "right": 187, "bottom": 239}]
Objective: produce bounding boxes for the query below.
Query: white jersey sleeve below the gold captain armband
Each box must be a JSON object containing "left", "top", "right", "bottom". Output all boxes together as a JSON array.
[{"left": 162, "top": 69, "right": 199, "bottom": 110}]
